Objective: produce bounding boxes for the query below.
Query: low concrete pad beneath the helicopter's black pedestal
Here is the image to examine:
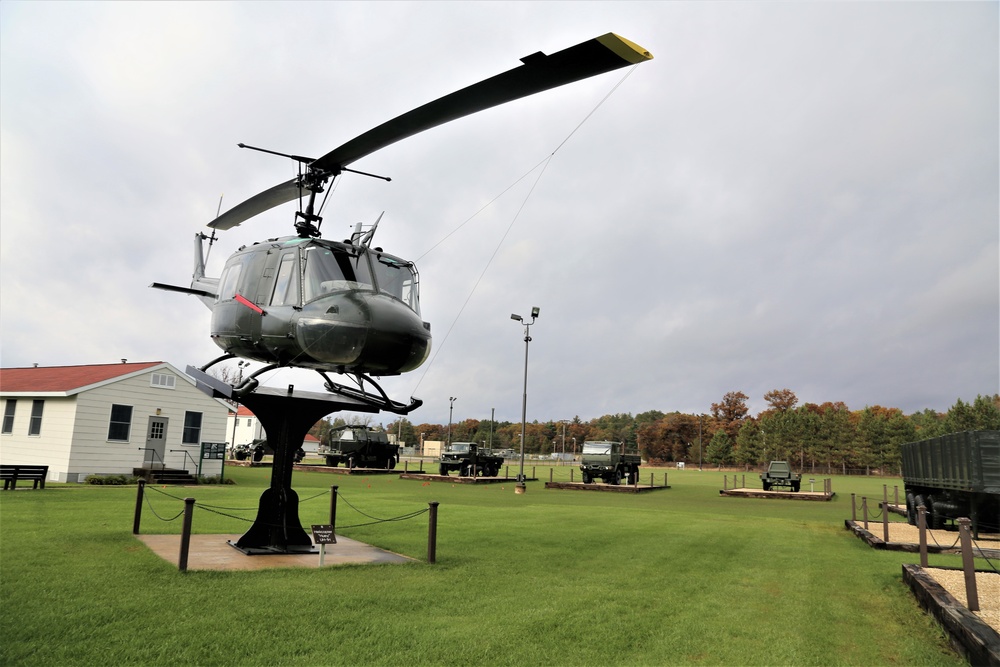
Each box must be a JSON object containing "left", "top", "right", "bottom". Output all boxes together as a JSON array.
[{"left": 136, "top": 535, "right": 418, "bottom": 570}]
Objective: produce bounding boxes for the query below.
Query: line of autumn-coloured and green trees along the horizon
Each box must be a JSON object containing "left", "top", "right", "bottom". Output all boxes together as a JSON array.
[{"left": 312, "top": 389, "right": 1000, "bottom": 474}]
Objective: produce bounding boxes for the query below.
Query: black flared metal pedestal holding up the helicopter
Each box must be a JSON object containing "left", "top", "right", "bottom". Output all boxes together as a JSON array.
[{"left": 186, "top": 366, "right": 406, "bottom": 555}]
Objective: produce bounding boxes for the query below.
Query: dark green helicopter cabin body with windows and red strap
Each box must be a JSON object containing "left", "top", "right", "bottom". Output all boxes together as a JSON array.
[{"left": 210, "top": 236, "right": 431, "bottom": 376}]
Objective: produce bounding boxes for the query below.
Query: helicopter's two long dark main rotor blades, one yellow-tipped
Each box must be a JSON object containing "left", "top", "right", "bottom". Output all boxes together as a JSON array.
[{"left": 208, "top": 32, "right": 653, "bottom": 229}]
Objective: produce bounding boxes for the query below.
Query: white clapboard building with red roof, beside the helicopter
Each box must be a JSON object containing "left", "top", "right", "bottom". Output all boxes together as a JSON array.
[{"left": 0, "top": 361, "right": 230, "bottom": 482}]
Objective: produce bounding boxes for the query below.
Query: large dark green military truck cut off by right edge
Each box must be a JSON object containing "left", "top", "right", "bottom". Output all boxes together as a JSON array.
[{"left": 900, "top": 431, "right": 1000, "bottom": 533}]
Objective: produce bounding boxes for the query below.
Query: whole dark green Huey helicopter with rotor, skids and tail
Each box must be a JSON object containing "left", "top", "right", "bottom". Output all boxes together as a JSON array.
[{"left": 151, "top": 33, "right": 652, "bottom": 414}]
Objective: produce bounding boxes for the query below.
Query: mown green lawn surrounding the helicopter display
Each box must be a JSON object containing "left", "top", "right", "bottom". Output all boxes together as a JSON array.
[{"left": 0, "top": 466, "right": 964, "bottom": 665}]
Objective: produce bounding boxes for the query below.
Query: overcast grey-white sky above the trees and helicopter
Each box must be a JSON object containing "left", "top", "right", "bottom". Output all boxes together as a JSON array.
[{"left": 0, "top": 0, "right": 1000, "bottom": 423}]
